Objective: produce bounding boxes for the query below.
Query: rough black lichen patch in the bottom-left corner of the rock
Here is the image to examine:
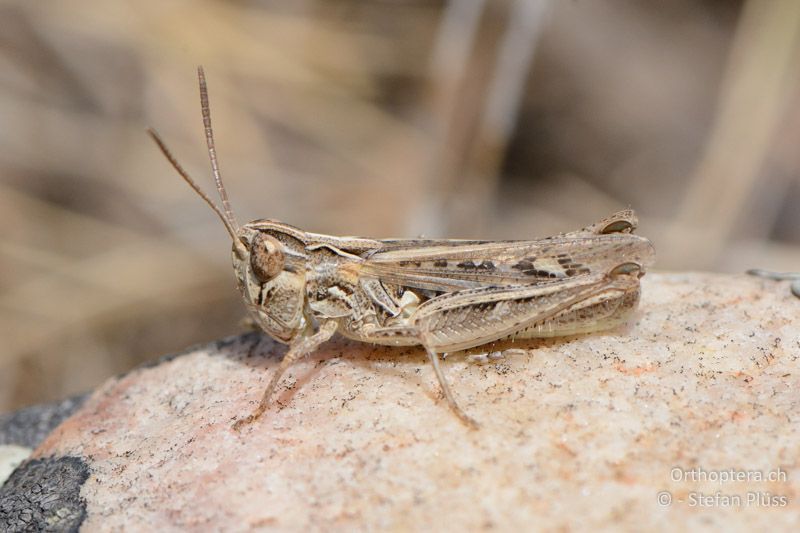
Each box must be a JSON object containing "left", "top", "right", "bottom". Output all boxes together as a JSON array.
[{"left": 0, "top": 457, "right": 89, "bottom": 532}]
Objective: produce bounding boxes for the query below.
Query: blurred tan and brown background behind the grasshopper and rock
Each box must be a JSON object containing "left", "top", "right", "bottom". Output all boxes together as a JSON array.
[{"left": 0, "top": 0, "right": 800, "bottom": 412}]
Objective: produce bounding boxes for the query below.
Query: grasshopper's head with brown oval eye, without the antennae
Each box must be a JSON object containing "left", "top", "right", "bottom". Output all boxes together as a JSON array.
[{"left": 231, "top": 221, "right": 306, "bottom": 342}]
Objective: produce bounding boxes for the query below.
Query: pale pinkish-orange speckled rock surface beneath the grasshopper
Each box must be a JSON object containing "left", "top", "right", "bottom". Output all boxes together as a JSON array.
[{"left": 7, "top": 273, "right": 800, "bottom": 531}]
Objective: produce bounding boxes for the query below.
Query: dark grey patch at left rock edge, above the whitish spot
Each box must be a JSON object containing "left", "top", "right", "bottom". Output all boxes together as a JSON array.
[{"left": 0, "top": 394, "right": 88, "bottom": 448}]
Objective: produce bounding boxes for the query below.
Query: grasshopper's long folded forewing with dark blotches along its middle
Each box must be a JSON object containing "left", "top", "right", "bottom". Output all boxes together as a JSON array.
[{"left": 360, "top": 234, "right": 654, "bottom": 291}]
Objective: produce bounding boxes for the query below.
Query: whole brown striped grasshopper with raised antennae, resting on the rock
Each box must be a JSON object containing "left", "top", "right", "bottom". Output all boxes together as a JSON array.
[{"left": 148, "top": 67, "right": 655, "bottom": 430}]
